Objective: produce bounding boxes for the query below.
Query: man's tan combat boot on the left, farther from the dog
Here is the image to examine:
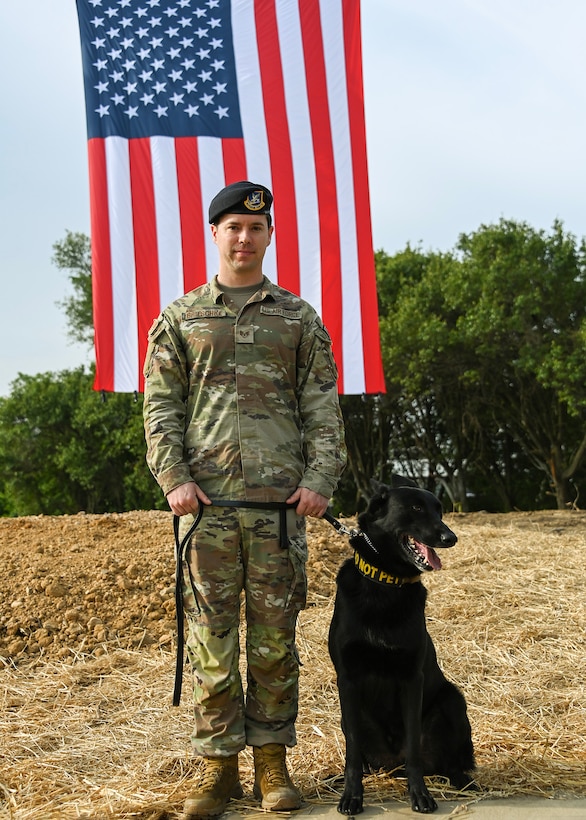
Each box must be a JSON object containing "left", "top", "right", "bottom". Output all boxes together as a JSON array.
[{"left": 183, "top": 755, "right": 244, "bottom": 820}]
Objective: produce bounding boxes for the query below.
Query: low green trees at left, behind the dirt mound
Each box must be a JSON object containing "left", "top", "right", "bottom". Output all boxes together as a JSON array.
[{"left": 0, "top": 367, "right": 166, "bottom": 515}]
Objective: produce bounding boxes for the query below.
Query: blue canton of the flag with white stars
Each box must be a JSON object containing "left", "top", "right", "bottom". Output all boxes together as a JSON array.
[{"left": 77, "top": 0, "right": 242, "bottom": 139}]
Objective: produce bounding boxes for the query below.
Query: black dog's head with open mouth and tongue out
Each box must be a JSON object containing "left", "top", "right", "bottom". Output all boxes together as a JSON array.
[{"left": 358, "top": 481, "right": 458, "bottom": 574}]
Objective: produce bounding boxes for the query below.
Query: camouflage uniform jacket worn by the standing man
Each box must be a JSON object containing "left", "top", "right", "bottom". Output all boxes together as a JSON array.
[{"left": 144, "top": 277, "right": 346, "bottom": 501}]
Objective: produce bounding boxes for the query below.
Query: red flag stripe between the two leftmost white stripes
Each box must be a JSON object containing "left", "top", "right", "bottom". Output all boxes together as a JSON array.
[{"left": 128, "top": 138, "right": 161, "bottom": 390}]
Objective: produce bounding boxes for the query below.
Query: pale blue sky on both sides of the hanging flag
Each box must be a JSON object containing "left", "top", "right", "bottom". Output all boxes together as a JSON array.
[{"left": 0, "top": 0, "right": 586, "bottom": 396}]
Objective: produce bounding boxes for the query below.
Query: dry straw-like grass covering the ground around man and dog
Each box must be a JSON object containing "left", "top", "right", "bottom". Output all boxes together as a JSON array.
[{"left": 0, "top": 513, "right": 586, "bottom": 820}]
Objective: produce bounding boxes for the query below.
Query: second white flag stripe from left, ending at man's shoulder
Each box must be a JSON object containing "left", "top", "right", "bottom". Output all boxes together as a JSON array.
[{"left": 151, "top": 137, "right": 183, "bottom": 310}]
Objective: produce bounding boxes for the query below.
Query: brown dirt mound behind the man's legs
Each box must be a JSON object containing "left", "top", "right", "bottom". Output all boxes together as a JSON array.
[{"left": 0, "top": 512, "right": 350, "bottom": 662}]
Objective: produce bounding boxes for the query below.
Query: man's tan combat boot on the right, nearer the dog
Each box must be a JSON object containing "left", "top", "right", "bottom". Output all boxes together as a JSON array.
[{"left": 252, "top": 743, "right": 301, "bottom": 811}]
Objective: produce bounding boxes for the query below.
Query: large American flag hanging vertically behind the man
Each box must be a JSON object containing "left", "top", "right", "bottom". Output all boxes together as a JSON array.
[{"left": 77, "top": 0, "right": 385, "bottom": 394}]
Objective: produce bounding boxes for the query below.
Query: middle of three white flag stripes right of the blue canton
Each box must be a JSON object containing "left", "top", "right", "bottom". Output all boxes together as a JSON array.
[{"left": 276, "top": 0, "right": 322, "bottom": 314}]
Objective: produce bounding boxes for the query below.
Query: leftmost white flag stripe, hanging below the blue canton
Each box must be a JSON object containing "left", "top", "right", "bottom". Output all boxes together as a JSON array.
[{"left": 105, "top": 137, "right": 140, "bottom": 393}]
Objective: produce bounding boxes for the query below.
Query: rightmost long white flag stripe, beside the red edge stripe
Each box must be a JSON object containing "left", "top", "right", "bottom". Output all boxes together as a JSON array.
[{"left": 320, "top": 0, "right": 365, "bottom": 393}]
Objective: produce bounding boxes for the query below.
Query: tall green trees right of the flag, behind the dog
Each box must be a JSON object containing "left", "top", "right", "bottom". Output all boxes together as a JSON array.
[{"left": 380, "top": 220, "right": 586, "bottom": 509}]
